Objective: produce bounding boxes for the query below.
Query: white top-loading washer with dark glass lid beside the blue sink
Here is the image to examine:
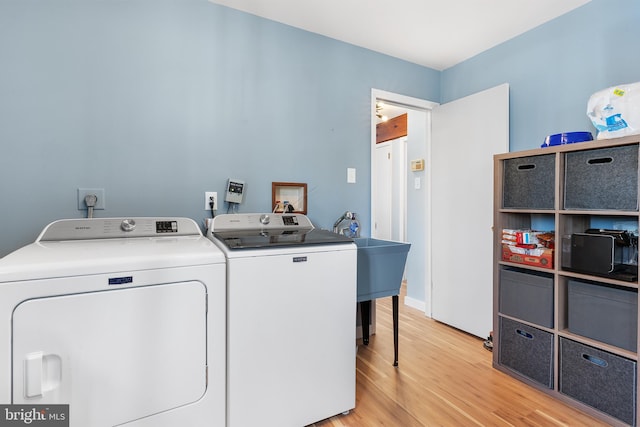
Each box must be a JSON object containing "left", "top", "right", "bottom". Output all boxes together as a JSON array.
[{"left": 208, "top": 213, "right": 357, "bottom": 427}]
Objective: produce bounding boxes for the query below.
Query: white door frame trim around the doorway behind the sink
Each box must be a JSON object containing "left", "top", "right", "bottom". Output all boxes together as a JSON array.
[{"left": 370, "top": 89, "right": 439, "bottom": 317}]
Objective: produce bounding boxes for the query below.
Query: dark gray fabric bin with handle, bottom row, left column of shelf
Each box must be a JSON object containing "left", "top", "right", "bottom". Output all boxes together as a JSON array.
[{"left": 498, "top": 316, "right": 553, "bottom": 388}]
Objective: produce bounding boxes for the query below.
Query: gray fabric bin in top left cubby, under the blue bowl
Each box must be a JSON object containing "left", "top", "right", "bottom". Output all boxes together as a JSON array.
[{"left": 502, "top": 154, "right": 556, "bottom": 209}]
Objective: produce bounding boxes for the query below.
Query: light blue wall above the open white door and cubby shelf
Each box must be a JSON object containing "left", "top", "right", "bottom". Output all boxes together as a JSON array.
[{"left": 440, "top": 0, "right": 640, "bottom": 151}]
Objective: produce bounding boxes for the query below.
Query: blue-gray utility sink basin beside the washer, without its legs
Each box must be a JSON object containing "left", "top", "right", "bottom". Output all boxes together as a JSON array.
[{"left": 353, "top": 237, "right": 411, "bottom": 302}]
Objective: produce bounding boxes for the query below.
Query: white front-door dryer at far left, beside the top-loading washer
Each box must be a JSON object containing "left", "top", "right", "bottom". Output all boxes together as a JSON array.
[{"left": 0, "top": 218, "right": 226, "bottom": 427}]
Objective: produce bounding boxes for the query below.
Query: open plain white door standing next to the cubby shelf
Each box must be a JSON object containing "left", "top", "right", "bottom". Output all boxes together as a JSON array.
[{"left": 430, "top": 84, "right": 509, "bottom": 337}]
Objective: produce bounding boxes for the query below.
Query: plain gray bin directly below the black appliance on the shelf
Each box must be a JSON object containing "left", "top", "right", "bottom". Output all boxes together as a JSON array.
[{"left": 568, "top": 280, "right": 638, "bottom": 352}]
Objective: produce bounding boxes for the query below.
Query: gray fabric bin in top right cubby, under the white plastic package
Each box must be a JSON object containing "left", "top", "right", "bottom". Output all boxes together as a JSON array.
[{"left": 564, "top": 145, "right": 638, "bottom": 211}]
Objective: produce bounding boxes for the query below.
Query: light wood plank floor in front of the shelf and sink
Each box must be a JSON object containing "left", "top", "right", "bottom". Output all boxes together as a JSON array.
[{"left": 313, "top": 293, "right": 607, "bottom": 427}]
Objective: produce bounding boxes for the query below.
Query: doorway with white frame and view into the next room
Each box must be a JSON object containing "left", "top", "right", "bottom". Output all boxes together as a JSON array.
[{"left": 370, "top": 89, "right": 438, "bottom": 316}]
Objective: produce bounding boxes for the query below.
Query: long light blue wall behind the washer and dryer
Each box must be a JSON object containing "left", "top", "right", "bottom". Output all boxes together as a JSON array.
[{"left": 0, "top": 0, "right": 440, "bottom": 256}]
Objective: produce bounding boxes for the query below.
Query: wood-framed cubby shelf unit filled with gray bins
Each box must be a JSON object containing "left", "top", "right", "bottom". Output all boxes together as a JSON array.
[{"left": 493, "top": 135, "right": 640, "bottom": 426}]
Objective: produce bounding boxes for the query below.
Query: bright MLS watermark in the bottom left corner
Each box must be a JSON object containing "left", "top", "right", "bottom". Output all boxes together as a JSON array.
[{"left": 0, "top": 405, "right": 69, "bottom": 427}]
